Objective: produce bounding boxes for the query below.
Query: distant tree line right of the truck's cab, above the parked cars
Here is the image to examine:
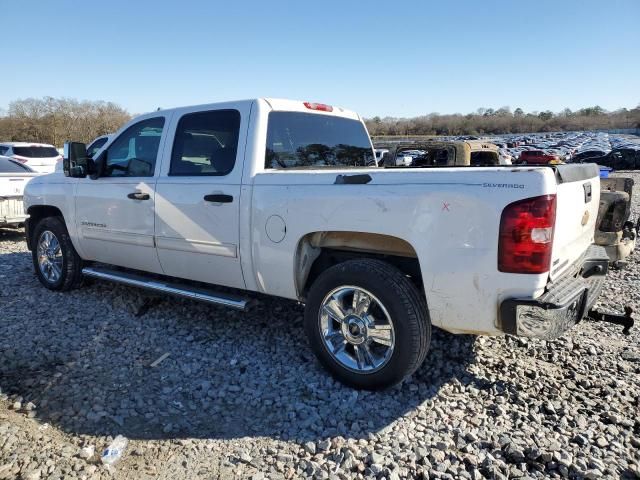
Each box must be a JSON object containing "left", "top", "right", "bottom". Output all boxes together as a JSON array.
[{"left": 365, "top": 105, "right": 640, "bottom": 136}]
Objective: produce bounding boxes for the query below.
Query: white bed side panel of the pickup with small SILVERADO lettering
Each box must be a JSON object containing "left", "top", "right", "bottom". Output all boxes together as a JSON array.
[{"left": 250, "top": 167, "right": 556, "bottom": 333}]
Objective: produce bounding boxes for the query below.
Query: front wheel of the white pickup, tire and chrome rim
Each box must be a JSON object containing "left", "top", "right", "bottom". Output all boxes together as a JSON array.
[{"left": 31, "top": 217, "right": 82, "bottom": 291}]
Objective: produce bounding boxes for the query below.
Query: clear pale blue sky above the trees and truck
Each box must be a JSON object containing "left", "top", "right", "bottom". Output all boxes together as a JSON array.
[{"left": 0, "top": 0, "right": 640, "bottom": 117}]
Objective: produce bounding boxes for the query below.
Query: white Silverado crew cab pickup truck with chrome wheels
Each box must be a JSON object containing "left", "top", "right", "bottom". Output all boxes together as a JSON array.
[{"left": 25, "top": 99, "right": 628, "bottom": 389}]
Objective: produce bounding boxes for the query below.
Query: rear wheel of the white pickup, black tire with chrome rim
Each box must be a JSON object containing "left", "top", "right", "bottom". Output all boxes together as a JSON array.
[{"left": 305, "top": 259, "right": 431, "bottom": 390}]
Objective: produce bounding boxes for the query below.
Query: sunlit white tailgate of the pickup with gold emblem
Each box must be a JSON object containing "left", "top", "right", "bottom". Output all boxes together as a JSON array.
[{"left": 550, "top": 164, "right": 600, "bottom": 280}]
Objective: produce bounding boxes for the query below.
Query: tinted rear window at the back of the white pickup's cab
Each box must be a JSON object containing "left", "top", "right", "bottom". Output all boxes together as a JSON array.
[{"left": 265, "top": 112, "right": 375, "bottom": 169}]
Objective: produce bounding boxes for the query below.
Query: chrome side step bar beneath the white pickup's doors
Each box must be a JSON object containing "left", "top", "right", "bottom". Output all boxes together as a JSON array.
[{"left": 82, "top": 267, "right": 249, "bottom": 311}]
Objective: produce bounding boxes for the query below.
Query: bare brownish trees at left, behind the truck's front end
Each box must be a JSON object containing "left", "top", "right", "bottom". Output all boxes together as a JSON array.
[{"left": 0, "top": 97, "right": 131, "bottom": 147}]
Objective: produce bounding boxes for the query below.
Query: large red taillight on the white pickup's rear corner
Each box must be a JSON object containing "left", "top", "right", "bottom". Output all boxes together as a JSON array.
[{"left": 498, "top": 195, "right": 556, "bottom": 273}]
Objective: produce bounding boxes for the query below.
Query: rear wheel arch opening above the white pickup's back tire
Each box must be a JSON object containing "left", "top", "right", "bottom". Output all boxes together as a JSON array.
[{"left": 294, "top": 231, "right": 424, "bottom": 298}]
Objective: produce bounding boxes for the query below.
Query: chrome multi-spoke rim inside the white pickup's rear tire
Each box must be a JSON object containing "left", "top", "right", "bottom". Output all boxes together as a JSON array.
[{"left": 318, "top": 286, "right": 395, "bottom": 373}]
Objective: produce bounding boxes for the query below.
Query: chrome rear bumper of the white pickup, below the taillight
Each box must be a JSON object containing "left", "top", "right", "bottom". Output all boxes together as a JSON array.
[{"left": 500, "top": 245, "right": 609, "bottom": 339}]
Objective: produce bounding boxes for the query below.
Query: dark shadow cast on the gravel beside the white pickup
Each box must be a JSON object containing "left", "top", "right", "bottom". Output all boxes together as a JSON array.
[{"left": 0, "top": 248, "right": 494, "bottom": 441}]
